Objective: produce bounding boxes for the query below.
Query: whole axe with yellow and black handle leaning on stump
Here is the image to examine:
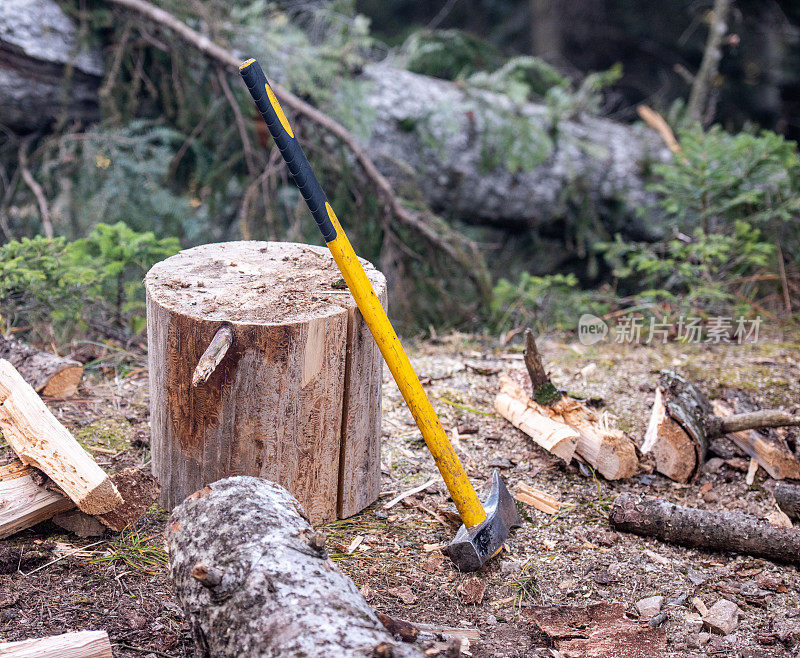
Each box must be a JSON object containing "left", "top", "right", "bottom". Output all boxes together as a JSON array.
[{"left": 239, "top": 59, "right": 521, "bottom": 571}]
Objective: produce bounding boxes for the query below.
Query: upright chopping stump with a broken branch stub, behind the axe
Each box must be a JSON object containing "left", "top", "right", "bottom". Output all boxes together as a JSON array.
[{"left": 145, "top": 242, "right": 386, "bottom": 523}]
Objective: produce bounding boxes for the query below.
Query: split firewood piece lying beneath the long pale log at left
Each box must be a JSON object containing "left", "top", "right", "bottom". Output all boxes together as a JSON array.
[{"left": 0, "top": 460, "right": 75, "bottom": 539}]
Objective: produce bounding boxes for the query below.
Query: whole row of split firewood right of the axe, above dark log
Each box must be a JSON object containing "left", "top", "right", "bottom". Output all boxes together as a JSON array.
[{"left": 494, "top": 329, "right": 800, "bottom": 492}]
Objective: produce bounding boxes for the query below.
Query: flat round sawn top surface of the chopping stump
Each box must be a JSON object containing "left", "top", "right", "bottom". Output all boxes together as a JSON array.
[{"left": 145, "top": 241, "right": 385, "bottom": 325}]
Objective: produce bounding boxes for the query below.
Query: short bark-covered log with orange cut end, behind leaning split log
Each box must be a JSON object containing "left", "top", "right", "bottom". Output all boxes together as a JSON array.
[{"left": 0, "top": 335, "right": 83, "bottom": 397}]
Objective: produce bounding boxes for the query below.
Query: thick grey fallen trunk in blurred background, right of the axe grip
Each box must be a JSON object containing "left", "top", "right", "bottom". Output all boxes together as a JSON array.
[{"left": 363, "top": 64, "right": 670, "bottom": 231}]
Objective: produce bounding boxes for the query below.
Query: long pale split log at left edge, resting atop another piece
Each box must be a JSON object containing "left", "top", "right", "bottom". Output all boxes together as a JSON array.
[{"left": 0, "top": 359, "right": 122, "bottom": 514}]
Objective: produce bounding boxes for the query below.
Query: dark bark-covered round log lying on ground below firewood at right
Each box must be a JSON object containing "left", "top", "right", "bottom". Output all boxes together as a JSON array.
[{"left": 608, "top": 493, "right": 800, "bottom": 564}]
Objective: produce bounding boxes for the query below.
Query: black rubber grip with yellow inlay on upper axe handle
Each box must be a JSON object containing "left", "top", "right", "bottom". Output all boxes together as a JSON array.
[{"left": 239, "top": 60, "right": 336, "bottom": 242}]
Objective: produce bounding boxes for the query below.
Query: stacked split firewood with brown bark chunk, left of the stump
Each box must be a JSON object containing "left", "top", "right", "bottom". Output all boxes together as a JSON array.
[{"left": 0, "top": 359, "right": 158, "bottom": 538}]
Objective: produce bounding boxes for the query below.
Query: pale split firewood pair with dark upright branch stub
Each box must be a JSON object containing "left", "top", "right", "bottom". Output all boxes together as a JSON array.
[{"left": 495, "top": 329, "right": 639, "bottom": 480}]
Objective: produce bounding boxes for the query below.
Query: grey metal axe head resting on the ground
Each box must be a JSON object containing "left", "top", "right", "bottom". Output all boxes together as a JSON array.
[{"left": 444, "top": 471, "right": 522, "bottom": 571}]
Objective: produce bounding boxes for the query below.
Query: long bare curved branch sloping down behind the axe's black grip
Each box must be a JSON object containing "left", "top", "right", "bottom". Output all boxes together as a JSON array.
[{"left": 99, "top": 0, "right": 492, "bottom": 301}]
